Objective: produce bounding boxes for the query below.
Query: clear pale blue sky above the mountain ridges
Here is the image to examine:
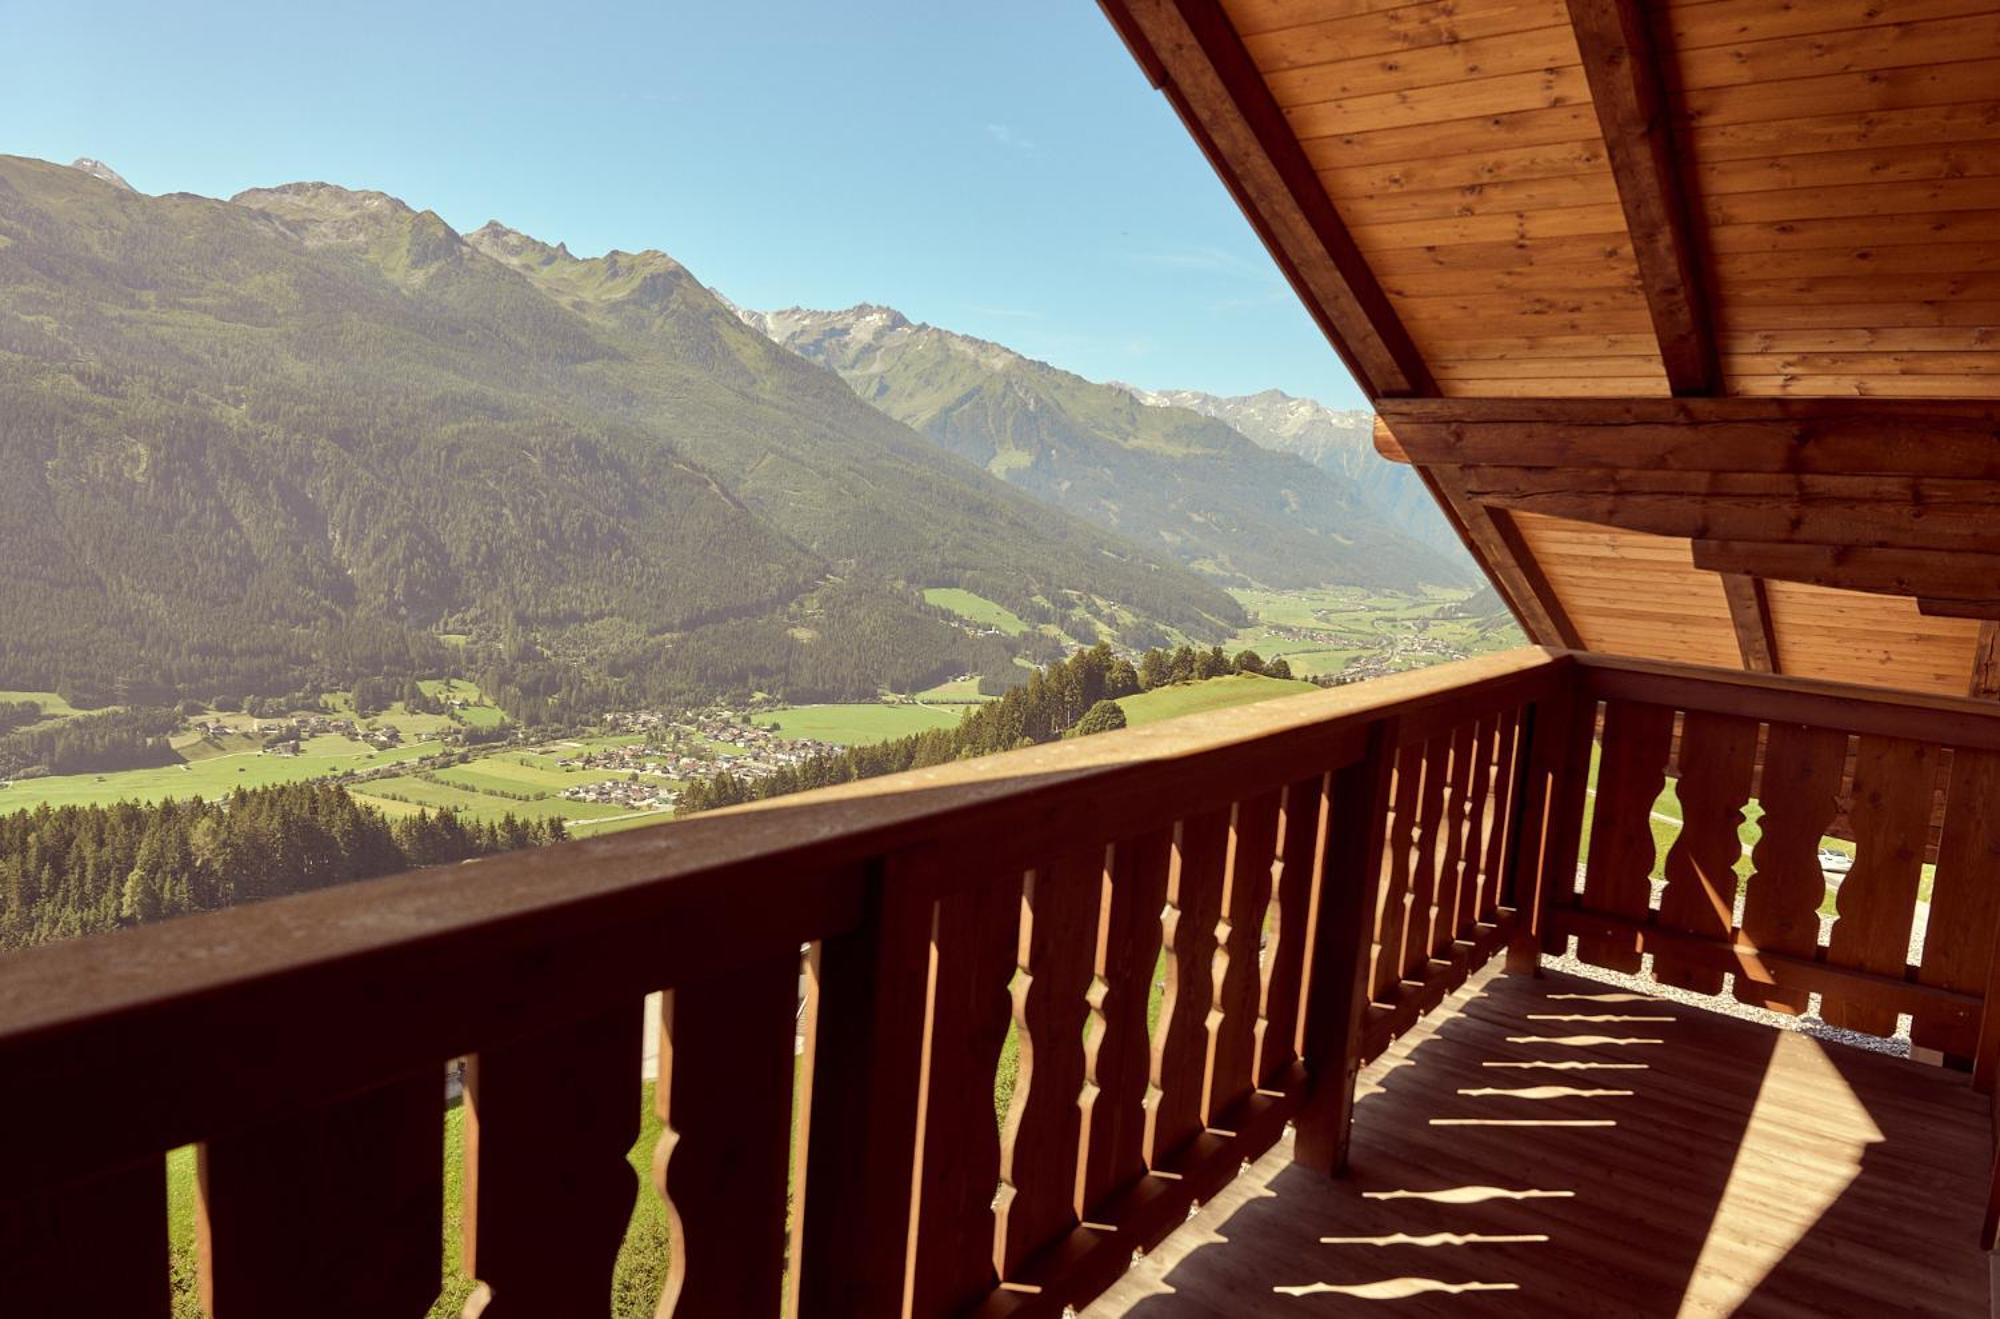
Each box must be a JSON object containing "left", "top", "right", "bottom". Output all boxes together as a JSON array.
[{"left": 0, "top": 0, "right": 1360, "bottom": 406}]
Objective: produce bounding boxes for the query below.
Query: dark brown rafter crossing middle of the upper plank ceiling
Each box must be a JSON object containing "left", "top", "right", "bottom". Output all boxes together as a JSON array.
[{"left": 1568, "top": 0, "right": 1722, "bottom": 396}]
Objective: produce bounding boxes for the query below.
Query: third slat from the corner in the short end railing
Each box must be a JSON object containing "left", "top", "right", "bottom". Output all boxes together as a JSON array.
[{"left": 1736, "top": 713, "right": 1848, "bottom": 1015}]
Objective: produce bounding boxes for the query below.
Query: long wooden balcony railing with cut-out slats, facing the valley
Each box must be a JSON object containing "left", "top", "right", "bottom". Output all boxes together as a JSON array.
[{"left": 0, "top": 652, "right": 1574, "bottom": 1319}]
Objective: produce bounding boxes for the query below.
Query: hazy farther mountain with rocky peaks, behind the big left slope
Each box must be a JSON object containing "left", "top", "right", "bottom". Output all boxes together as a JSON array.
[{"left": 744, "top": 306, "right": 1472, "bottom": 588}]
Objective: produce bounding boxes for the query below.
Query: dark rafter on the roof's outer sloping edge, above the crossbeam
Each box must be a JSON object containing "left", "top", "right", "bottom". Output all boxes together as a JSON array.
[{"left": 1102, "top": 0, "right": 1430, "bottom": 398}]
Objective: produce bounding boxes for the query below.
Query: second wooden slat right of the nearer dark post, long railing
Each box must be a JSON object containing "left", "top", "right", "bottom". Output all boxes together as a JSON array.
[{"left": 994, "top": 847, "right": 1110, "bottom": 1279}]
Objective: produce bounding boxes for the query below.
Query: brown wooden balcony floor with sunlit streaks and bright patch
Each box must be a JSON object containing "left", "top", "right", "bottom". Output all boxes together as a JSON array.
[{"left": 1086, "top": 975, "right": 1992, "bottom": 1319}]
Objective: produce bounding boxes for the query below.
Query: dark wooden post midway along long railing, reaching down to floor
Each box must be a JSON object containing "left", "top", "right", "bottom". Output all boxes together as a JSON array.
[{"left": 1292, "top": 719, "right": 1398, "bottom": 1175}]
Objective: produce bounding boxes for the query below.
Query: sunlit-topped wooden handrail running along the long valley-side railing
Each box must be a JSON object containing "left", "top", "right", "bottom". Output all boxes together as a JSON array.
[{"left": 0, "top": 650, "right": 1568, "bottom": 1193}]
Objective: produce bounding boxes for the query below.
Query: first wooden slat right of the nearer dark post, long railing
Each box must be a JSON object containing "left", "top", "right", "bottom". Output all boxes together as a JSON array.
[{"left": 904, "top": 871, "right": 1024, "bottom": 1315}]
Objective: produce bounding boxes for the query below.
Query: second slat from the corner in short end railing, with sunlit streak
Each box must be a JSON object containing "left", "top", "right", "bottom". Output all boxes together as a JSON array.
[{"left": 1652, "top": 709, "right": 1758, "bottom": 993}]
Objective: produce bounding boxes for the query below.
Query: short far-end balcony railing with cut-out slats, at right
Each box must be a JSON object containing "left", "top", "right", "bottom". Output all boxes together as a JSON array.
[{"left": 1540, "top": 656, "right": 2000, "bottom": 1069}]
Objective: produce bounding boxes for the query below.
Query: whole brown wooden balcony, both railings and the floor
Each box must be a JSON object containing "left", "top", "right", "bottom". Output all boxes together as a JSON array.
[{"left": 0, "top": 650, "right": 2000, "bottom": 1319}]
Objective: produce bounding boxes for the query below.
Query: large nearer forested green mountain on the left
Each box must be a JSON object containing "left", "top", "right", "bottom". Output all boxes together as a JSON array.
[{"left": 0, "top": 156, "right": 1240, "bottom": 715}]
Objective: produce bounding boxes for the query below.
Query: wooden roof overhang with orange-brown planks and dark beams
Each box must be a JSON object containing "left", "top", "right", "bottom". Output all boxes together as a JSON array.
[{"left": 1102, "top": 0, "right": 2000, "bottom": 695}]
